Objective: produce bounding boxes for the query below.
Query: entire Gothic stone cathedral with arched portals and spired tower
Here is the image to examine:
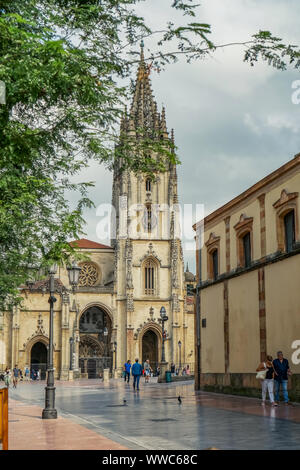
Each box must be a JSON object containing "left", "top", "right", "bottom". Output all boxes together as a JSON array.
[{"left": 0, "top": 46, "right": 195, "bottom": 380}]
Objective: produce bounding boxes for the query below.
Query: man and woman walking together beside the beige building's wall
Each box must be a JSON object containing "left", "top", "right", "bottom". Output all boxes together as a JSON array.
[{"left": 256, "top": 351, "right": 292, "bottom": 406}]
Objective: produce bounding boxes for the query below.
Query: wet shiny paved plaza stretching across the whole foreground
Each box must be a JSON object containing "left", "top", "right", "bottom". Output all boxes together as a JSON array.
[{"left": 4, "top": 379, "right": 300, "bottom": 450}]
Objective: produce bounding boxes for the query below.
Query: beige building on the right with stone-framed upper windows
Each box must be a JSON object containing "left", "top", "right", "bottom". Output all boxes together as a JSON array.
[{"left": 194, "top": 154, "right": 300, "bottom": 400}]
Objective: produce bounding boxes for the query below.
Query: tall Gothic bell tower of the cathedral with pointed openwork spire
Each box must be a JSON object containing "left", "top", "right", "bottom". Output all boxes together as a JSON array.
[{"left": 112, "top": 47, "right": 194, "bottom": 374}]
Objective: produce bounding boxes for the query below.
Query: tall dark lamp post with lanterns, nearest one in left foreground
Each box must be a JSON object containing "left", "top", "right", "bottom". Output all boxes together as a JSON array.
[{"left": 42, "top": 262, "right": 81, "bottom": 419}]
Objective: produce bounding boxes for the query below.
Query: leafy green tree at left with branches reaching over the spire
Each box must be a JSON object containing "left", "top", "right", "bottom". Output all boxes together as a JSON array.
[{"left": 0, "top": 0, "right": 299, "bottom": 307}]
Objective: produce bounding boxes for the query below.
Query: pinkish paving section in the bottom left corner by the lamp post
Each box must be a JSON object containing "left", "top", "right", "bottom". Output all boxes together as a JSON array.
[{"left": 9, "top": 399, "right": 126, "bottom": 450}]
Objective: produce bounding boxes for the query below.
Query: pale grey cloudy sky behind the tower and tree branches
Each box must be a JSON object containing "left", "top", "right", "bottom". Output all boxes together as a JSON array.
[{"left": 69, "top": 0, "right": 300, "bottom": 270}]
